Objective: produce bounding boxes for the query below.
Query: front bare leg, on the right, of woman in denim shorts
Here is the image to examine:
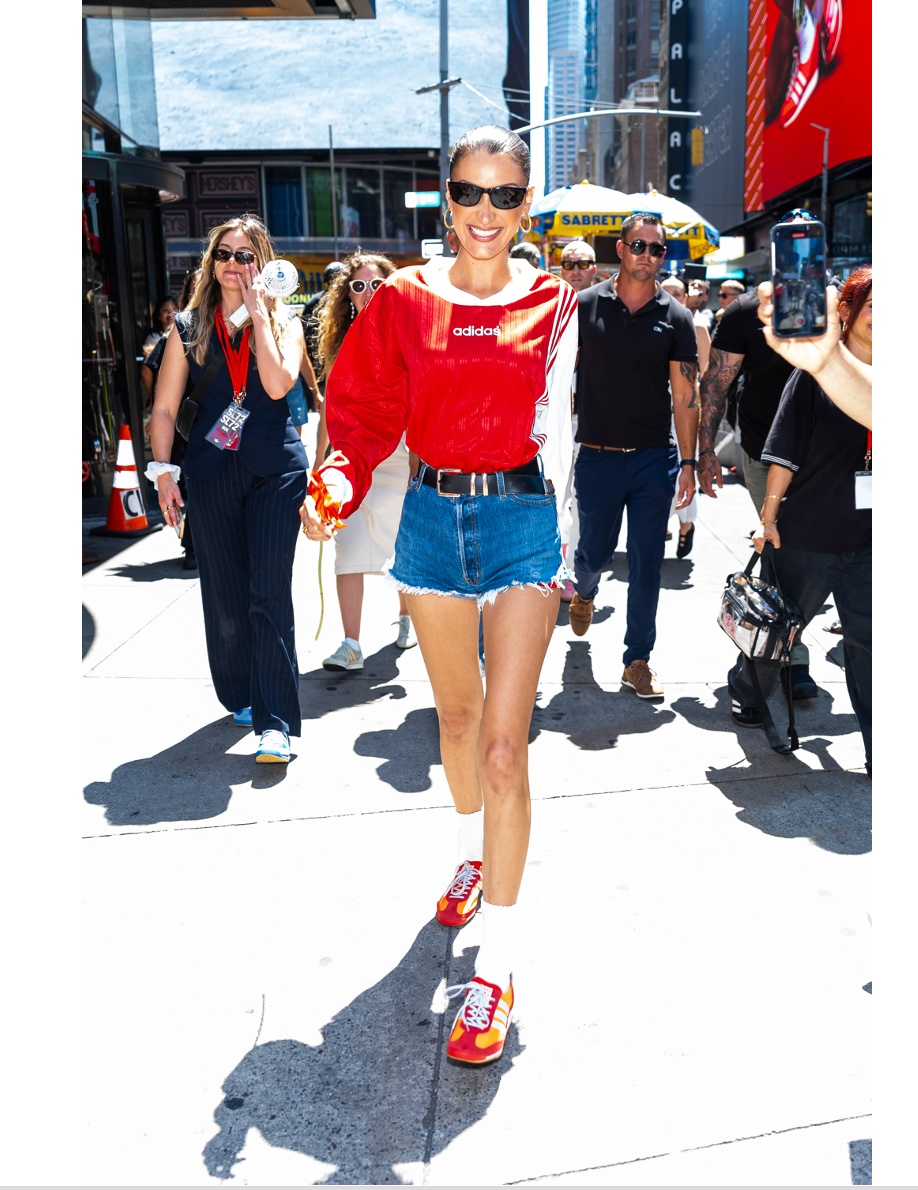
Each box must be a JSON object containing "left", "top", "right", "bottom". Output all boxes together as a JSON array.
[{"left": 477, "top": 587, "right": 561, "bottom": 906}]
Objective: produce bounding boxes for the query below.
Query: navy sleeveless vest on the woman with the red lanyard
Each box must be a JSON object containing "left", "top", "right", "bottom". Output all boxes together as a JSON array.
[{"left": 175, "top": 313, "right": 308, "bottom": 480}]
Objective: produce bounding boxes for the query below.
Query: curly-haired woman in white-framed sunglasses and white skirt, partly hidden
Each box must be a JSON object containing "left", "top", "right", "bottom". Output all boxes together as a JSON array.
[{"left": 316, "top": 252, "right": 418, "bottom": 670}]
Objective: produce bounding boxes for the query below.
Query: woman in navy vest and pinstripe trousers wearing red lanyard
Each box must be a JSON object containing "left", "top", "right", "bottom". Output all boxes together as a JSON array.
[{"left": 146, "top": 215, "right": 308, "bottom": 763}]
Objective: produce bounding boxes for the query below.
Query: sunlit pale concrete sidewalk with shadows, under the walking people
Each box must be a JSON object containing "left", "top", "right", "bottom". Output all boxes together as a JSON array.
[{"left": 83, "top": 459, "right": 872, "bottom": 1186}]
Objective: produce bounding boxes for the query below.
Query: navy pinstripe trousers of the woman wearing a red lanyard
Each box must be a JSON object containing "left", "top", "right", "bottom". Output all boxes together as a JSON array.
[{"left": 188, "top": 452, "right": 306, "bottom": 735}]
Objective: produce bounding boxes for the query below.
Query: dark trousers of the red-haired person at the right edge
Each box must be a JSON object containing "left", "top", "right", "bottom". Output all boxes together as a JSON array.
[{"left": 726, "top": 545, "right": 873, "bottom": 764}]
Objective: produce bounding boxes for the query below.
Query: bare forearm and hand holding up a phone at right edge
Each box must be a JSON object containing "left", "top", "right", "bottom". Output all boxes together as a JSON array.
[{"left": 757, "top": 281, "right": 873, "bottom": 430}]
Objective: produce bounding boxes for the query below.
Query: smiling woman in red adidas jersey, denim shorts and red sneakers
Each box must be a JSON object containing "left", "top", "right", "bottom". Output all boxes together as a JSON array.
[{"left": 302, "top": 125, "right": 577, "bottom": 1065}]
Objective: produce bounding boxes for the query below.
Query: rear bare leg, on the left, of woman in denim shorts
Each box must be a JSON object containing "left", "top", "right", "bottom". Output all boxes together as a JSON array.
[{"left": 406, "top": 595, "right": 485, "bottom": 814}]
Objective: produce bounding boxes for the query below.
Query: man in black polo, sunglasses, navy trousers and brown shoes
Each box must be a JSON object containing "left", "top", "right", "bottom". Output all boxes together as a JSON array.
[{"left": 570, "top": 214, "right": 698, "bottom": 699}]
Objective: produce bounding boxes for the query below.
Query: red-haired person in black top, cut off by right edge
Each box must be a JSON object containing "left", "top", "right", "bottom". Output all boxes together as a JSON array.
[{"left": 727, "top": 264, "right": 873, "bottom": 772}]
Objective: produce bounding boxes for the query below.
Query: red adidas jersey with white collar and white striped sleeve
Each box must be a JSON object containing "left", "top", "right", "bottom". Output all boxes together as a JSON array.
[{"left": 325, "top": 261, "right": 577, "bottom": 518}]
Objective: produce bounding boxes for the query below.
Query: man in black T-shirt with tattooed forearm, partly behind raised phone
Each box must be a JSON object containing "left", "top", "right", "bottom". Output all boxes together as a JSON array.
[{"left": 698, "top": 212, "right": 819, "bottom": 699}]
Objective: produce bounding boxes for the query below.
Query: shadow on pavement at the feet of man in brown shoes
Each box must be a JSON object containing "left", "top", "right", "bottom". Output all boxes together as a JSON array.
[{"left": 529, "top": 640, "right": 676, "bottom": 752}]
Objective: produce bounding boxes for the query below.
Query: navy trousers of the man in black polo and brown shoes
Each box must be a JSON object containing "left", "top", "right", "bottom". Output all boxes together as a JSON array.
[{"left": 574, "top": 446, "right": 673, "bottom": 666}]
